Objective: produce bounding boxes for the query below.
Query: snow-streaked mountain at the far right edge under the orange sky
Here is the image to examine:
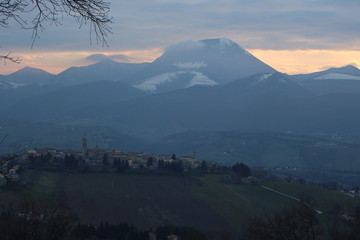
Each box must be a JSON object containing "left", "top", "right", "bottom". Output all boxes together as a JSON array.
[{"left": 290, "top": 65, "right": 360, "bottom": 95}]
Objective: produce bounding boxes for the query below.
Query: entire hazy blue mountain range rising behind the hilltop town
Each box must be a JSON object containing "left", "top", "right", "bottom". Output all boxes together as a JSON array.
[{"left": 0, "top": 39, "right": 360, "bottom": 171}]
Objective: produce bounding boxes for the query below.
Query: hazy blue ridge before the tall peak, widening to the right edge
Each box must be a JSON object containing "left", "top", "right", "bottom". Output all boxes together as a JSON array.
[{"left": 45, "top": 71, "right": 360, "bottom": 134}]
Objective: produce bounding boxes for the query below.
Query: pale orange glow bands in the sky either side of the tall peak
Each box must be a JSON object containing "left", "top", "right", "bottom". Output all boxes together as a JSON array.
[{"left": 0, "top": 48, "right": 360, "bottom": 75}]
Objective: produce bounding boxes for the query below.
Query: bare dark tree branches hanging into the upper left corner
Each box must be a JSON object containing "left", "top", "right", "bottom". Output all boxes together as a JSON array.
[{"left": 0, "top": 0, "right": 112, "bottom": 63}]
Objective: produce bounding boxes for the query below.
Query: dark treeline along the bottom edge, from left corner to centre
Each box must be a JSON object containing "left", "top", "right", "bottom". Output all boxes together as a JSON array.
[{"left": 0, "top": 200, "right": 207, "bottom": 240}]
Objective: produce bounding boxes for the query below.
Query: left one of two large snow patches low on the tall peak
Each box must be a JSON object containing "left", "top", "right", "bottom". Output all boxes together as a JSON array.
[{"left": 134, "top": 71, "right": 186, "bottom": 92}]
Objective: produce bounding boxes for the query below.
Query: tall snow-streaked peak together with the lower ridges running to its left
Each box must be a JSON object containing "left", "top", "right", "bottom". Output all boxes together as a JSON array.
[{"left": 0, "top": 38, "right": 275, "bottom": 93}]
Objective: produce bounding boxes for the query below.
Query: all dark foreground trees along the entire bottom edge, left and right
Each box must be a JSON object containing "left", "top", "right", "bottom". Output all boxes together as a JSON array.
[{"left": 0, "top": 201, "right": 360, "bottom": 240}]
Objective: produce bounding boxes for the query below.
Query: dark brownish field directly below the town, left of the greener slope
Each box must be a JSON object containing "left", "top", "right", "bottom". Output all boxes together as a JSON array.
[{"left": 59, "top": 173, "right": 234, "bottom": 232}]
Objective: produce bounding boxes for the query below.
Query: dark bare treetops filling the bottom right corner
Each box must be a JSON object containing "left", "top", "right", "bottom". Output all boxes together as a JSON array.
[{"left": 244, "top": 204, "right": 360, "bottom": 240}]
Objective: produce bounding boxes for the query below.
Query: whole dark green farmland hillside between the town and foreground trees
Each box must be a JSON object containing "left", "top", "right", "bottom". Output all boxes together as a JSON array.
[{"left": 0, "top": 170, "right": 360, "bottom": 233}]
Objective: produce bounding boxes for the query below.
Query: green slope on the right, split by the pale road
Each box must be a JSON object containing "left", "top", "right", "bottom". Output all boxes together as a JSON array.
[{"left": 191, "top": 175, "right": 360, "bottom": 229}]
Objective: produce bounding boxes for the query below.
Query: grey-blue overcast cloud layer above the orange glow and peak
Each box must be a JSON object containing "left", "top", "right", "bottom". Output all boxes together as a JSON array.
[{"left": 0, "top": 0, "right": 360, "bottom": 51}]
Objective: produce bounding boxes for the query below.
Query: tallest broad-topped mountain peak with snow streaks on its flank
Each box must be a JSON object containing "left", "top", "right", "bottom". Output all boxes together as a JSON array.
[{"left": 134, "top": 38, "right": 275, "bottom": 92}]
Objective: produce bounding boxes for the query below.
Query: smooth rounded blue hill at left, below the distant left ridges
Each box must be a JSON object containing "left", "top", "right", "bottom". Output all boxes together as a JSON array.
[{"left": 3, "top": 81, "right": 147, "bottom": 121}]
